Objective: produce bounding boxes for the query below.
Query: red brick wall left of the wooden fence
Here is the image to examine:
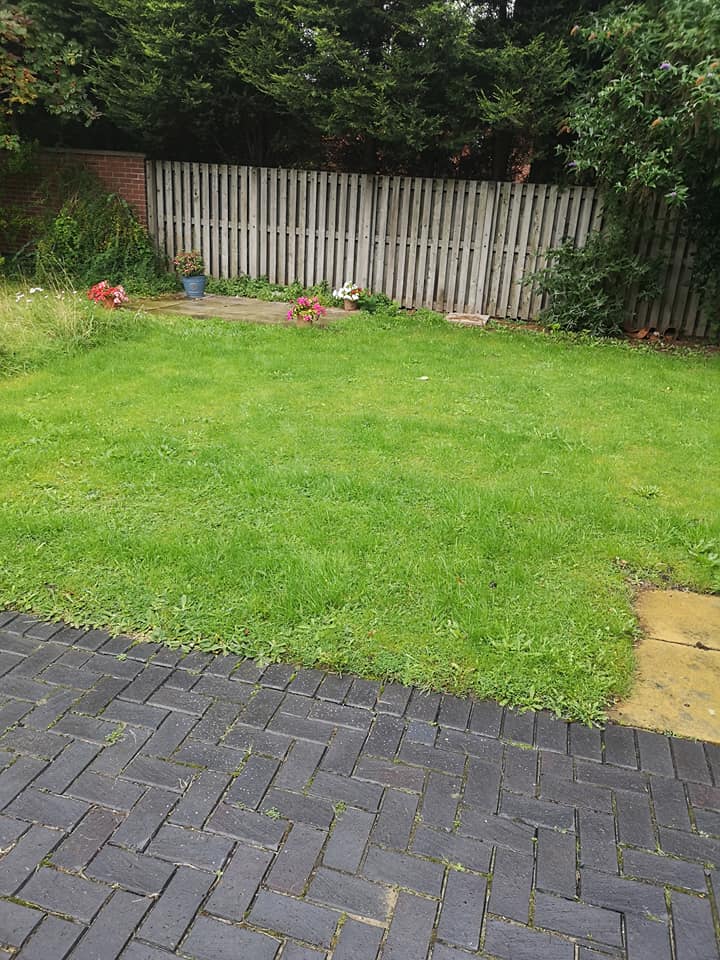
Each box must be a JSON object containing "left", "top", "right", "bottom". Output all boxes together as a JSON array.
[{"left": 0, "top": 150, "right": 148, "bottom": 249}]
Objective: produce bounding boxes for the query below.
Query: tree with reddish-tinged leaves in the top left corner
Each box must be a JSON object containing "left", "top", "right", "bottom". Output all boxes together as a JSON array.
[{"left": 0, "top": 6, "right": 96, "bottom": 156}]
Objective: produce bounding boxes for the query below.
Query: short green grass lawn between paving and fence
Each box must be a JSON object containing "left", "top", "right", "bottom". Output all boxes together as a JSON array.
[{"left": 0, "top": 314, "right": 720, "bottom": 720}]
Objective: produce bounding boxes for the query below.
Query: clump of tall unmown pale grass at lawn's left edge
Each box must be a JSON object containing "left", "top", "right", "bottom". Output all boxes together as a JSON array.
[{"left": 0, "top": 284, "right": 146, "bottom": 377}]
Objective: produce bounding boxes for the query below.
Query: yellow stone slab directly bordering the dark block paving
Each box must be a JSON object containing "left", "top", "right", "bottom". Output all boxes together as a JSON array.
[{"left": 609, "top": 637, "right": 720, "bottom": 743}]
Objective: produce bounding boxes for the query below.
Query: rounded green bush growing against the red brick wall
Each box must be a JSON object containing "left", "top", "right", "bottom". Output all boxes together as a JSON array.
[{"left": 35, "top": 189, "right": 175, "bottom": 292}]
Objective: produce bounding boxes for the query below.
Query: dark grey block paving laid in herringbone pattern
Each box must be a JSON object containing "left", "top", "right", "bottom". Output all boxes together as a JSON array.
[{"left": 0, "top": 612, "right": 720, "bottom": 960}]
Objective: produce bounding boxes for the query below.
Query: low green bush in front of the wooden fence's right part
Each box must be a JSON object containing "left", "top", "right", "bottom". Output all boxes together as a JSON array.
[{"left": 525, "top": 229, "right": 659, "bottom": 337}]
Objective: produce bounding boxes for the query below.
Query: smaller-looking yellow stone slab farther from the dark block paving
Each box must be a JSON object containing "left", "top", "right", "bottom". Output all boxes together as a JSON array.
[{"left": 636, "top": 590, "right": 720, "bottom": 650}]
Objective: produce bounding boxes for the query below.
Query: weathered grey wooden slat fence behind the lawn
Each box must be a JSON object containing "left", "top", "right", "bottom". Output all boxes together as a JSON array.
[{"left": 147, "top": 161, "right": 706, "bottom": 336}]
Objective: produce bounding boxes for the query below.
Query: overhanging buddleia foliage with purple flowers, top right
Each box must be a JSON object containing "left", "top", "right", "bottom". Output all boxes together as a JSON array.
[{"left": 568, "top": 0, "right": 720, "bottom": 300}]
